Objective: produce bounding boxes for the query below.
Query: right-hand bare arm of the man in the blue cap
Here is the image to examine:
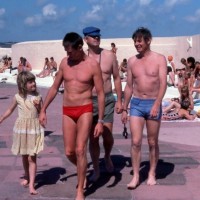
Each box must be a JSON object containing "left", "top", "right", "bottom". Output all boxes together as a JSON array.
[{"left": 113, "top": 55, "right": 122, "bottom": 114}]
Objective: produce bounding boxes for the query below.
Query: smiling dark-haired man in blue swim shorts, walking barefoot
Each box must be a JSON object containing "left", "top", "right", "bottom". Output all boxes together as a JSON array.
[{"left": 122, "top": 27, "right": 167, "bottom": 189}]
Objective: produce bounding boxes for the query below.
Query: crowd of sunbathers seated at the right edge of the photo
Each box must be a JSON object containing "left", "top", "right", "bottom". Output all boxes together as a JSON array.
[{"left": 162, "top": 56, "right": 200, "bottom": 120}]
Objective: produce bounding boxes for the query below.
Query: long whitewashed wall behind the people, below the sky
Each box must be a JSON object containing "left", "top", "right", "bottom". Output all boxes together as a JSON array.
[{"left": 12, "top": 35, "right": 200, "bottom": 69}]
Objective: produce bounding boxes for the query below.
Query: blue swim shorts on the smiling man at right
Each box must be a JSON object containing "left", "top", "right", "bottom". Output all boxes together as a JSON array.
[{"left": 130, "top": 97, "right": 162, "bottom": 120}]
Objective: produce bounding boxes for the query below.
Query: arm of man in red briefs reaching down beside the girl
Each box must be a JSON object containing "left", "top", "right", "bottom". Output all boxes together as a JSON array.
[{"left": 39, "top": 63, "right": 63, "bottom": 126}]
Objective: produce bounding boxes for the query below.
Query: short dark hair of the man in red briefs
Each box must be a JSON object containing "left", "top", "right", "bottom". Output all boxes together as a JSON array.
[{"left": 63, "top": 32, "right": 83, "bottom": 49}]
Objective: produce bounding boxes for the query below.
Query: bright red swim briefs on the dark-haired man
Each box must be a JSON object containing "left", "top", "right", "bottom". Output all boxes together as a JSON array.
[{"left": 63, "top": 103, "right": 93, "bottom": 122}]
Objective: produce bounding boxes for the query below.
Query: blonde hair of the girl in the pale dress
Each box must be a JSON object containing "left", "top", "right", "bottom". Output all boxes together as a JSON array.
[{"left": 17, "top": 71, "right": 38, "bottom": 99}]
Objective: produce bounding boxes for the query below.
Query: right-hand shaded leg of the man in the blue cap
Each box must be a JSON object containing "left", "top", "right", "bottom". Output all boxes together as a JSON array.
[{"left": 102, "top": 123, "right": 114, "bottom": 173}]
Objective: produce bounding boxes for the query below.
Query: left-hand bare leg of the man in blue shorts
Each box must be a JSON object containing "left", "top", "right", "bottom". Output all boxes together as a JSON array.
[{"left": 127, "top": 116, "right": 145, "bottom": 189}]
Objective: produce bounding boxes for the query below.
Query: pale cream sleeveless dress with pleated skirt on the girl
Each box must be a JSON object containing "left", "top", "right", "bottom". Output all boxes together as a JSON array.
[{"left": 11, "top": 94, "right": 44, "bottom": 155}]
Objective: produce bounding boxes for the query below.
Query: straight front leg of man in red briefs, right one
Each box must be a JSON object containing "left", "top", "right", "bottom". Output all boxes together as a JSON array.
[{"left": 76, "top": 113, "right": 92, "bottom": 200}]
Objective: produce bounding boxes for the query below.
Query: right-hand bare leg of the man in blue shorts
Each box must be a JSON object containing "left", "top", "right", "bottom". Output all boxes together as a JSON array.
[{"left": 147, "top": 120, "right": 160, "bottom": 185}]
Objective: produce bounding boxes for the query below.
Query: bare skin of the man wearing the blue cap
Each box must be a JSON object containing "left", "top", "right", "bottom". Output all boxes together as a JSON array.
[{"left": 84, "top": 36, "right": 122, "bottom": 181}]
